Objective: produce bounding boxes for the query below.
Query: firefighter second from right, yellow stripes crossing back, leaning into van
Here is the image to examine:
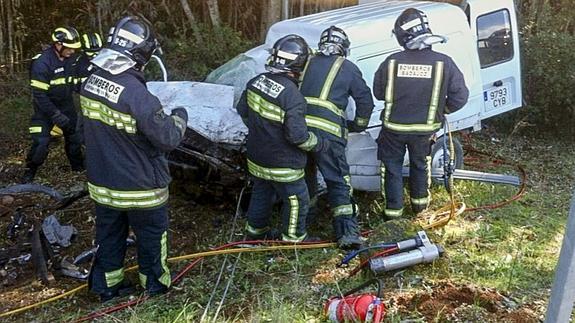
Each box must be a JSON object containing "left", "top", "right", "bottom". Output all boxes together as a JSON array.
[{"left": 300, "top": 26, "right": 373, "bottom": 248}]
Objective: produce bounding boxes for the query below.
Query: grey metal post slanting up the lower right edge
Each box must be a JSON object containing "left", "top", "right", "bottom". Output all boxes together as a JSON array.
[{"left": 545, "top": 190, "right": 575, "bottom": 323}]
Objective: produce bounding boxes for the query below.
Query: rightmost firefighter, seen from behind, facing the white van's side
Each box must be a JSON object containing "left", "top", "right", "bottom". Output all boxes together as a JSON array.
[{"left": 373, "top": 8, "right": 469, "bottom": 219}]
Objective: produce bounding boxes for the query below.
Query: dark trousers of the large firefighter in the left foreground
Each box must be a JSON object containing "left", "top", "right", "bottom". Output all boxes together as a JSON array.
[{"left": 89, "top": 204, "right": 171, "bottom": 294}]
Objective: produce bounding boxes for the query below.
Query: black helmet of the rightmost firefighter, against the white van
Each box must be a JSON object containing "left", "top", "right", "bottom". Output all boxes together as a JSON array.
[{"left": 393, "top": 8, "right": 431, "bottom": 48}]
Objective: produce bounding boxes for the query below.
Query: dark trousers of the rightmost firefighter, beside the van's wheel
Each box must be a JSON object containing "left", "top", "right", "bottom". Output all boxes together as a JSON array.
[{"left": 377, "top": 129, "right": 432, "bottom": 218}]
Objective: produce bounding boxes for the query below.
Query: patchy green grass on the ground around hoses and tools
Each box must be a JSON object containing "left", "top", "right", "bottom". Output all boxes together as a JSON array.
[{"left": 0, "top": 88, "right": 575, "bottom": 322}]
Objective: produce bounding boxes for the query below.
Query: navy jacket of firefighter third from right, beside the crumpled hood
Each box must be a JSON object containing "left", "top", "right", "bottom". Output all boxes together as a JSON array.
[{"left": 236, "top": 73, "right": 317, "bottom": 175}]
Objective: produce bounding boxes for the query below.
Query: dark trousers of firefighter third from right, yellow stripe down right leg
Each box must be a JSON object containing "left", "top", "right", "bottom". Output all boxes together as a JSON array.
[{"left": 246, "top": 177, "right": 309, "bottom": 242}]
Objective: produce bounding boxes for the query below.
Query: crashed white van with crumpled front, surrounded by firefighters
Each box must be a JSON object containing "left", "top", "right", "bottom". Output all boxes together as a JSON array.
[{"left": 149, "top": 0, "right": 522, "bottom": 191}]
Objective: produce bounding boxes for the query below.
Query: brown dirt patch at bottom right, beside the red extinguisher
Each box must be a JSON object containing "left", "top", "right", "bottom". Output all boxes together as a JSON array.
[{"left": 387, "top": 282, "right": 539, "bottom": 323}]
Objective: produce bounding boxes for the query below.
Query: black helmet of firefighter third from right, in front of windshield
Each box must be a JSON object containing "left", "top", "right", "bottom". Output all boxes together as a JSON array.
[{"left": 266, "top": 35, "right": 310, "bottom": 73}]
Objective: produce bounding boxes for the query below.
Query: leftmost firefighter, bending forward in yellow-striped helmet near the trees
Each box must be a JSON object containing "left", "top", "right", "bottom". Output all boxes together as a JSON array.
[{"left": 21, "top": 27, "right": 84, "bottom": 183}]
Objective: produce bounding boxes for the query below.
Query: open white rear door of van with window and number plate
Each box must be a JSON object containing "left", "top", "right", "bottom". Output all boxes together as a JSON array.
[{"left": 468, "top": 0, "right": 522, "bottom": 119}]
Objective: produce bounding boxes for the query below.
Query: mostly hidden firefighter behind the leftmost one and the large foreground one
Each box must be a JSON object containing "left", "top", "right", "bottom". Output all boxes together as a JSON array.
[{"left": 68, "top": 32, "right": 103, "bottom": 91}]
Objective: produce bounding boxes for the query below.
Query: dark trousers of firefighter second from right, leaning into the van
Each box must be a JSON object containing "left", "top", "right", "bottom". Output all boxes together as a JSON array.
[{"left": 305, "top": 136, "right": 356, "bottom": 216}]
